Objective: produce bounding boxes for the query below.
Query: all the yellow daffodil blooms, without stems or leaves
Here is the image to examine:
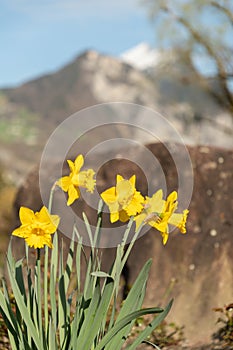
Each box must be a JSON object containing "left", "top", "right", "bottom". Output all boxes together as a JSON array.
[{"left": 12, "top": 155, "right": 189, "bottom": 248}]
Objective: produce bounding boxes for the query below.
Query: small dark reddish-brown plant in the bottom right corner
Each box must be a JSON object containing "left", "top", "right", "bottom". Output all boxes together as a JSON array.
[{"left": 212, "top": 303, "right": 233, "bottom": 345}]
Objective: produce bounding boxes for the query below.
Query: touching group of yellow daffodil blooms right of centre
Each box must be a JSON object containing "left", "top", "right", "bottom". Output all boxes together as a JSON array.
[{"left": 101, "top": 175, "right": 189, "bottom": 244}]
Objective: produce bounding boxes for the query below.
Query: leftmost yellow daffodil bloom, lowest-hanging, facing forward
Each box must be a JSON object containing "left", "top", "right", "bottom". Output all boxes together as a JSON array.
[{"left": 12, "top": 206, "right": 60, "bottom": 248}]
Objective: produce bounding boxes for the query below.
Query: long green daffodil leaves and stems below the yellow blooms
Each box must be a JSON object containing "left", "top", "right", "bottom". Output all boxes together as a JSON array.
[{"left": 0, "top": 203, "right": 172, "bottom": 350}]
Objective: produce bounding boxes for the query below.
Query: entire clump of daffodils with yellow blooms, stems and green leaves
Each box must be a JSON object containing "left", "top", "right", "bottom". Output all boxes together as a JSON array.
[{"left": 0, "top": 155, "right": 188, "bottom": 350}]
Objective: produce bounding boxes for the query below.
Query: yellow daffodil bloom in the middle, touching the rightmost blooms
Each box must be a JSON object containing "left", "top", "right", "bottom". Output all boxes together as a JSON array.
[{"left": 101, "top": 175, "right": 144, "bottom": 223}]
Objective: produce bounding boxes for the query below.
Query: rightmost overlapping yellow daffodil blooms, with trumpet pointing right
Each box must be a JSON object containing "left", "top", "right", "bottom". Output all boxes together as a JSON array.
[{"left": 135, "top": 190, "right": 189, "bottom": 244}]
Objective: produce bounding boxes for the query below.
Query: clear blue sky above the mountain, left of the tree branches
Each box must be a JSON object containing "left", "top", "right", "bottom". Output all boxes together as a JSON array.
[{"left": 0, "top": 0, "right": 155, "bottom": 87}]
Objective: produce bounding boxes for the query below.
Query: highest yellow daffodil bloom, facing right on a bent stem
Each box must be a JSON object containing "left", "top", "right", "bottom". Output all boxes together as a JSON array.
[{"left": 57, "top": 154, "right": 96, "bottom": 205}]
